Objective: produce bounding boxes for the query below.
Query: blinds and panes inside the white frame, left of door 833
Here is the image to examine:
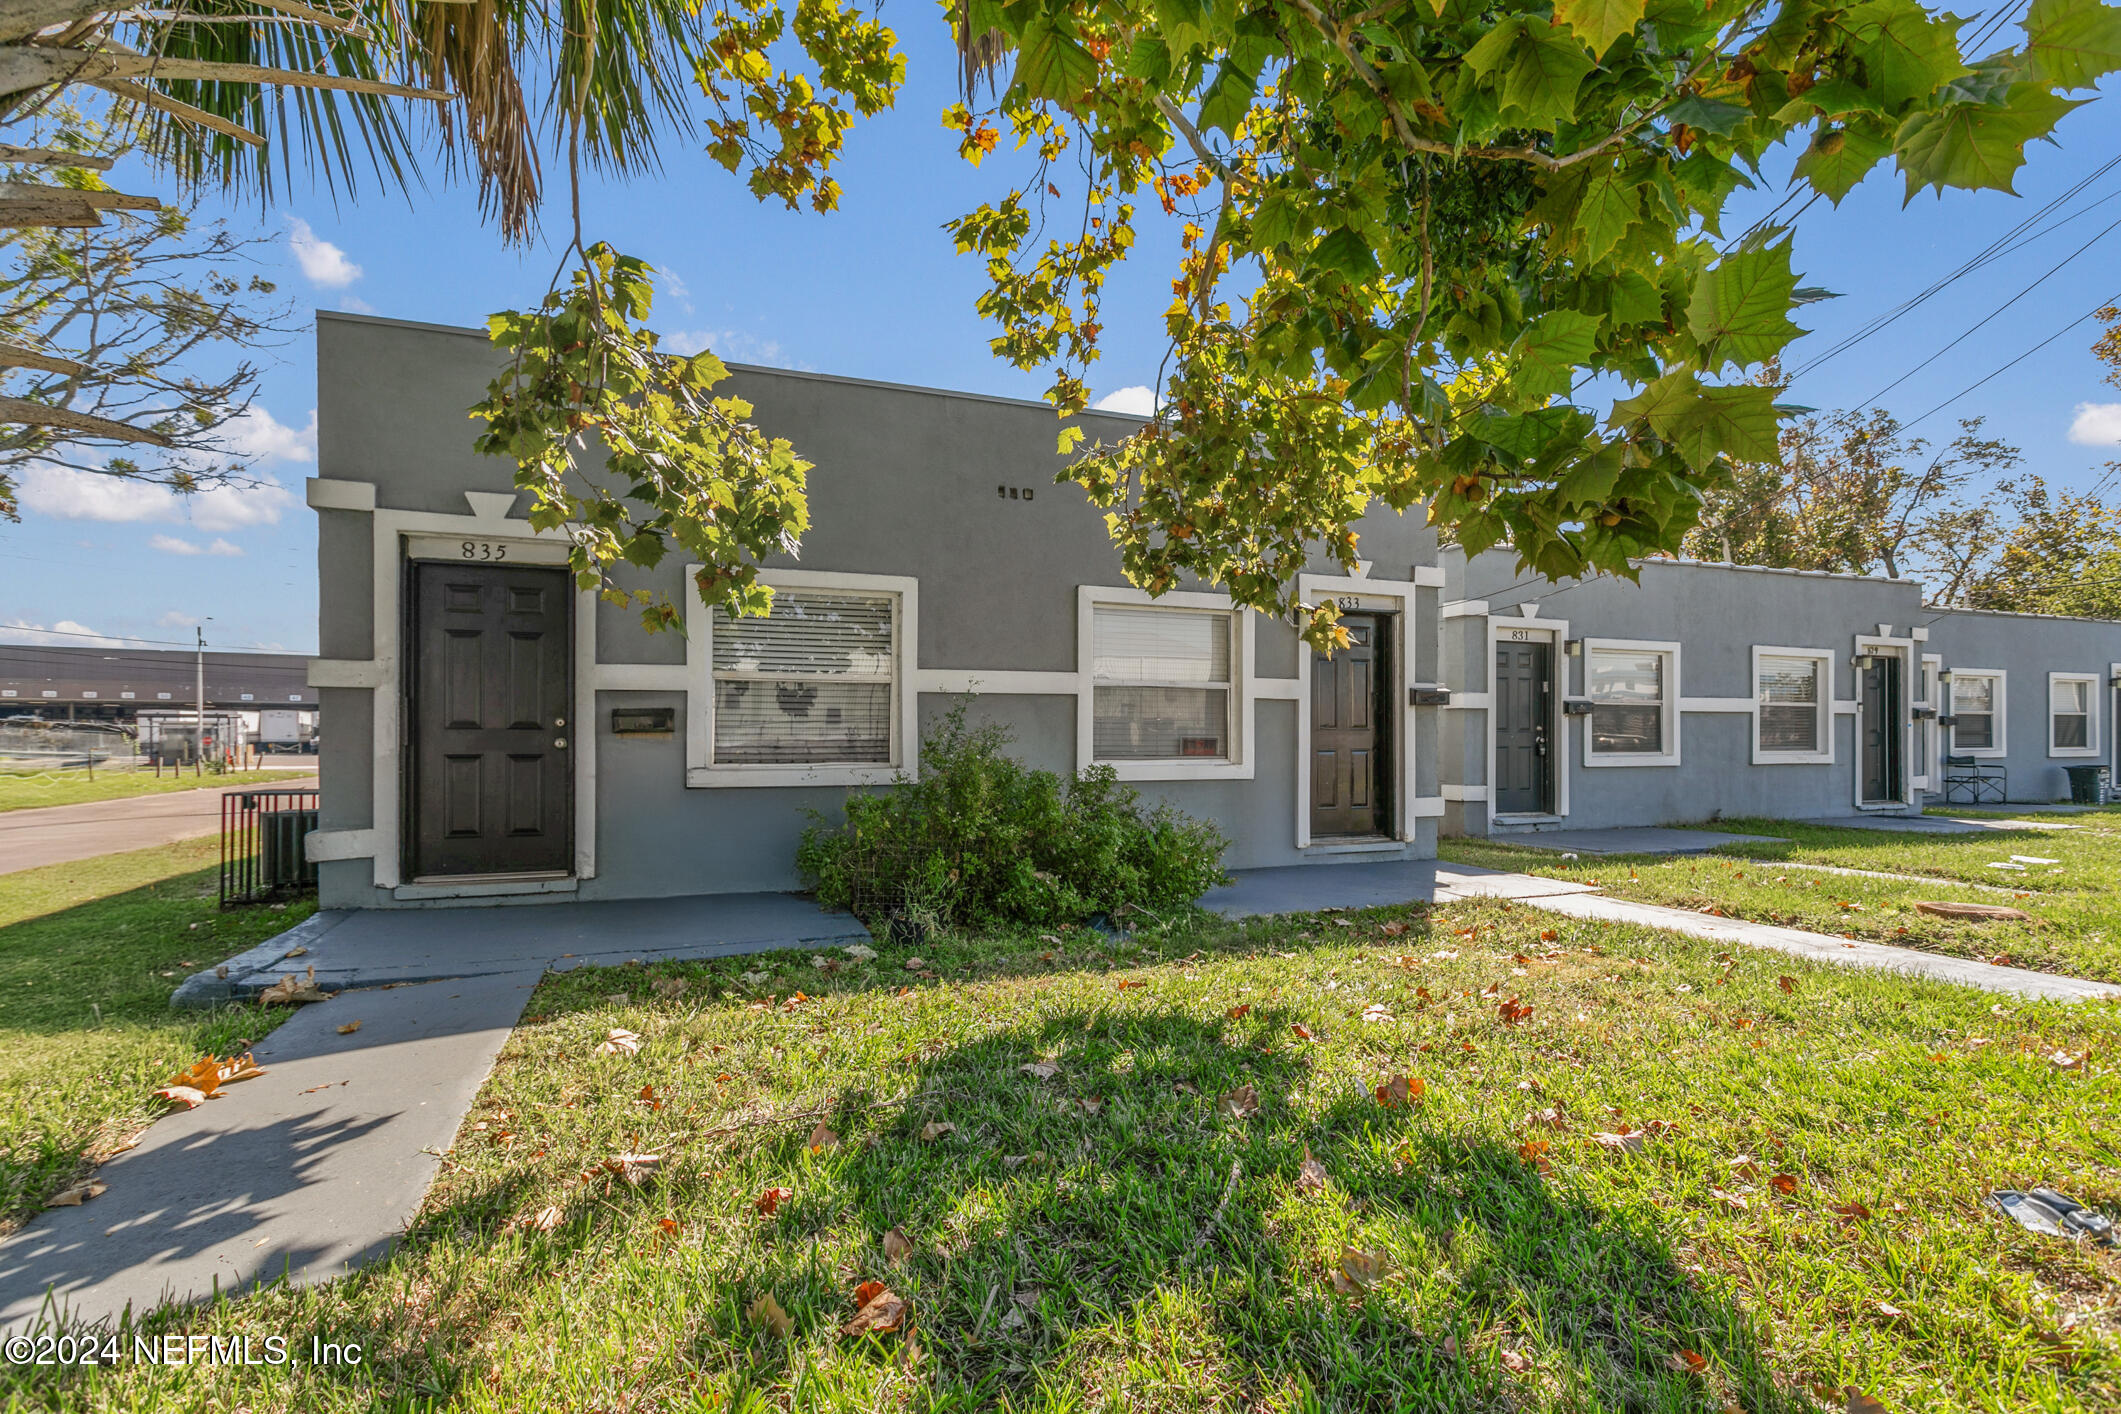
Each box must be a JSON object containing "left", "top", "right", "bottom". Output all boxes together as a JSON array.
[{"left": 1090, "top": 606, "right": 1232, "bottom": 761}]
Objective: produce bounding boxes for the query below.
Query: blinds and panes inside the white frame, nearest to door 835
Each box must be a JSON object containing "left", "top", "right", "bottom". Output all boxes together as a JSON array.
[{"left": 715, "top": 589, "right": 897, "bottom": 765}]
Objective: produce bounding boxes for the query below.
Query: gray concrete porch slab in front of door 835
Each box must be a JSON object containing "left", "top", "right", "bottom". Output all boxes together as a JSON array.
[{"left": 170, "top": 892, "right": 870, "bottom": 1007}]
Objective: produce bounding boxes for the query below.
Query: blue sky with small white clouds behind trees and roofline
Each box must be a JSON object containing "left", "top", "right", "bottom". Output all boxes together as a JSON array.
[{"left": 0, "top": 18, "right": 2121, "bottom": 651}]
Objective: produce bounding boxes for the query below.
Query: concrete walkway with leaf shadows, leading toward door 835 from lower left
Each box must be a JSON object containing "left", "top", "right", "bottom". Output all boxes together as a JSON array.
[{"left": 0, "top": 967, "right": 539, "bottom": 1333}]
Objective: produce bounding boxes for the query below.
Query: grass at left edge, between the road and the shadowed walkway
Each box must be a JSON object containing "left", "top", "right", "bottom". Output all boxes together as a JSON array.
[{"left": 0, "top": 839, "right": 312, "bottom": 1232}]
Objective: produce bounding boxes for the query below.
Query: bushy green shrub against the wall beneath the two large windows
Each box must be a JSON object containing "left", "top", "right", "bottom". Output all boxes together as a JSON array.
[{"left": 795, "top": 706, "right": 1228, "bottom": 933}]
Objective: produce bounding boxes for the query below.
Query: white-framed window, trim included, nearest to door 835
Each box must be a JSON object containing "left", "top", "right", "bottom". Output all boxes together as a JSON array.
[{"left": 685, "top": 570, "right": 918, "bottom": 786}]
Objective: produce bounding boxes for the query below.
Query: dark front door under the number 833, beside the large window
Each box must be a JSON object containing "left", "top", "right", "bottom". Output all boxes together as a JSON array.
[{"left": 1311, "top": 613, "right": 1391, "bottom": 839}]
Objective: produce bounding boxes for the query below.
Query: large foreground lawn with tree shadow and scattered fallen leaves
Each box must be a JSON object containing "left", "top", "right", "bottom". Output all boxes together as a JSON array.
[{"left": 20, "top": 903, "right": 2121, "bottom": 1414}]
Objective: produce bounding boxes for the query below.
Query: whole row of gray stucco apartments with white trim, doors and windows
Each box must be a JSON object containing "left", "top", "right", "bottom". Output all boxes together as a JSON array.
[{"left": 310, "top": 312, "right": 2121, "bottom": 907}]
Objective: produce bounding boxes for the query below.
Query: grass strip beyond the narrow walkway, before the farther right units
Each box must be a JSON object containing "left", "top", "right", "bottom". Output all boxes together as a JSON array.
[{"left": 1440, "top": 816, "right": 2121, "bottom": 982}]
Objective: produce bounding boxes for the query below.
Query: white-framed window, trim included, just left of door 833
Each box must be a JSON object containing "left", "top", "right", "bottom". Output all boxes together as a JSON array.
[{"left": 1075, "top": 587, "right": 1251, "bottom": 780}]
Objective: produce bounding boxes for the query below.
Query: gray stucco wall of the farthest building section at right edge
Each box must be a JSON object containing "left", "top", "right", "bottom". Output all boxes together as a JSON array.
[{"left": 1930, "top": 611, "right": 2121, "bottom": 801}]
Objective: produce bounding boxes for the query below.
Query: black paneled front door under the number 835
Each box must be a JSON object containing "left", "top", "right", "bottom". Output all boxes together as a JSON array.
[{"left": 409, "top": 564, "right": 581, "bottom": 878}]
